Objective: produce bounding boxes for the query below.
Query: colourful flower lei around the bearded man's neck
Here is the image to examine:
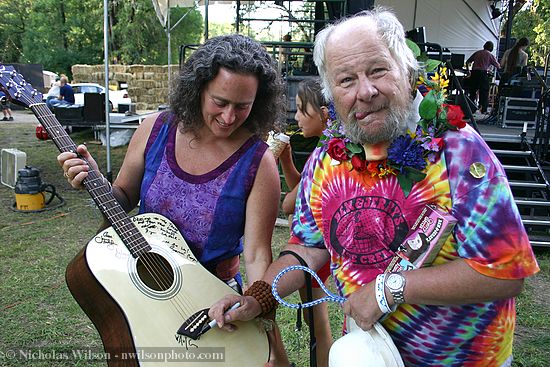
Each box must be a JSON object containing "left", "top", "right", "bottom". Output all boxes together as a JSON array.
[{"left": 322, "top": 68, "right": 466, "bottom": 196}]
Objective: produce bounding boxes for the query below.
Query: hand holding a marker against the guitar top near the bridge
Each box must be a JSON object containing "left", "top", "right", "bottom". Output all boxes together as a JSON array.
[{"left": 208, "top": 295, "right": 262, "bottom": 331}]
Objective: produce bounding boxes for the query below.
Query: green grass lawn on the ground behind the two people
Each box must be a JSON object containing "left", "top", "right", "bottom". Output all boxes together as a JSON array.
[{"left": 0, "top": 112, "right": 550, "bottom": 367}]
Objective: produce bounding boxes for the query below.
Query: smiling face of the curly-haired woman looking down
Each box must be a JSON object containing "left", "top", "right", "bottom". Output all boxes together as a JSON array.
[{"left": 201, "top": 68, "right": 258, "bottom": 138}]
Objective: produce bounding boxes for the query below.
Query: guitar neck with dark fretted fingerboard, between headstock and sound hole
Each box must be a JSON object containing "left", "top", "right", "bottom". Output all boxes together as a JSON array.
[{"left": 30, "top": 103, "right": 151, "bottom": 258}]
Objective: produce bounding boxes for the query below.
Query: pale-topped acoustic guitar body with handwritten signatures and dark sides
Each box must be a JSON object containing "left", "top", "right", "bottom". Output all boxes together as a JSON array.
[{"left": 66, "top": 214, "right": 269, "bottom": 366}]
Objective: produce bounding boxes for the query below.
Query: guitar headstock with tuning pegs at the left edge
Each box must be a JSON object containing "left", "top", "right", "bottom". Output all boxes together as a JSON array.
[{"left": 0, "top": 63, "right": 42, "bottom": 107}]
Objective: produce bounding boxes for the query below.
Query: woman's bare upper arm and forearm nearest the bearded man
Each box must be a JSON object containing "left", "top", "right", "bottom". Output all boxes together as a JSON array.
[{"left": 243, "top": 152, "right": 281, "bottom": 284}]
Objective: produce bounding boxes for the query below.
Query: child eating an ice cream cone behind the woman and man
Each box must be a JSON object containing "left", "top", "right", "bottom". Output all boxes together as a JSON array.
[{"left": 279, "top": 79, "right": 333, "bottom": 367}]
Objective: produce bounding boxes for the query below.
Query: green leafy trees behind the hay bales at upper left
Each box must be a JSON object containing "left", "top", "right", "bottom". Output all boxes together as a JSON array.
[{"left": 0, "top": 0, "right": 203, "bottom": 75}]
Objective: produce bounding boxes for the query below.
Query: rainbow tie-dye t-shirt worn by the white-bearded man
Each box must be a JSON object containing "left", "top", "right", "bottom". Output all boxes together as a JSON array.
[{"left": 291, "top": 126, "right": 538, "bottom": 367}]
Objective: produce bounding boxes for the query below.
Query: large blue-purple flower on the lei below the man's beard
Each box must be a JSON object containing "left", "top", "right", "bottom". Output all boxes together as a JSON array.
[{"left": 388, "top": 134, "right": 426, "bottom": 173}]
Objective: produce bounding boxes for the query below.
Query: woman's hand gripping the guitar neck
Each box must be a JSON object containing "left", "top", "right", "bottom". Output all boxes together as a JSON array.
[{"left": 57, "top": 145, "right": 98, "bottom": 189}]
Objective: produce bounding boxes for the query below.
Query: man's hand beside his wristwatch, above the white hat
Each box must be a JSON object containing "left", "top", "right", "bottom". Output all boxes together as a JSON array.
[{"left": 342, "top": 281, "right": 384, "bottom": 330}]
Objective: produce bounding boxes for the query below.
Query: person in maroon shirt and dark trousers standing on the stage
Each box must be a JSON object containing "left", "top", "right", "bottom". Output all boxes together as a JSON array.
[{"left": 466, "top": 41, "right": 500, "bottom": 114}]
